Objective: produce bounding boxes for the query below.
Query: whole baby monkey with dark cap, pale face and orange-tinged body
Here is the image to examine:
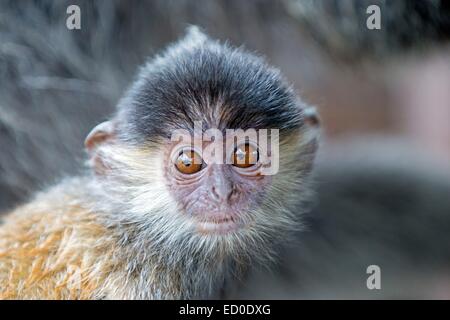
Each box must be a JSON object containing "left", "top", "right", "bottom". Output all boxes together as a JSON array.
[{"left": 0, "top": 27, "right": 318, "bottom": 299}]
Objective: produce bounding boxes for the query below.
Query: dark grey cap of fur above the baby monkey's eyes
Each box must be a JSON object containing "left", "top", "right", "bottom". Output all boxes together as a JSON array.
[{"left": 118, "top": 42, "right": 303, "bottom": 139}]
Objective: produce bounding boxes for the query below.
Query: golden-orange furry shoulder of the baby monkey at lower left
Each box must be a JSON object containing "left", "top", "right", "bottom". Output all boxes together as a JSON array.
[{"left": 0, "top": 178, "right": 122, "bottom": 299}]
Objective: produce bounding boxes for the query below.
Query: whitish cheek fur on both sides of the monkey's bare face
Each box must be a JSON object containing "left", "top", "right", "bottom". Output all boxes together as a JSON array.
[{"left": 93, "top": 127, "right": 309, "bottom": 243}]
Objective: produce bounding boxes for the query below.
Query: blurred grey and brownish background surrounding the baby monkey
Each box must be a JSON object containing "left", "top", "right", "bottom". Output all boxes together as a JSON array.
[{"left": 0, "top": 0, "right": 450, "bottom": 298}]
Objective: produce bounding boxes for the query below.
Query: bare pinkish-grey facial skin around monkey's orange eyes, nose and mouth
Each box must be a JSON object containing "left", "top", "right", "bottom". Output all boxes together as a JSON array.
[{"left": 164, "top": 135, "right": 271, "bottom": 234}]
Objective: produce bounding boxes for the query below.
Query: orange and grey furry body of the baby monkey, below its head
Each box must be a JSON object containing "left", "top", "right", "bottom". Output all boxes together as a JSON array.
[{"left": 0, "top": 179, "right": 239, "bottom": 299}]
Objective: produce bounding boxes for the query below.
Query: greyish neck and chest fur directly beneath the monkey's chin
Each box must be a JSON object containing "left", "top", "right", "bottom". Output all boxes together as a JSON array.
[{"left": 111, "top": 222, "right": 247, "bottom": 299}]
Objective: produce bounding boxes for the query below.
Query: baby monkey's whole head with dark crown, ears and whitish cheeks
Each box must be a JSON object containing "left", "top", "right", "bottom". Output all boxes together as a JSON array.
[{"left": 82, "top": 28, "right": 318, "bottom": 266}]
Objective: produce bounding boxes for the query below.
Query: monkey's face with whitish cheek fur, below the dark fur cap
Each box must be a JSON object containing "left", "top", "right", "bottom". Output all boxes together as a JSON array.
[{"left": 84, "top": 121, "right": 316, "bottom": 239}]
